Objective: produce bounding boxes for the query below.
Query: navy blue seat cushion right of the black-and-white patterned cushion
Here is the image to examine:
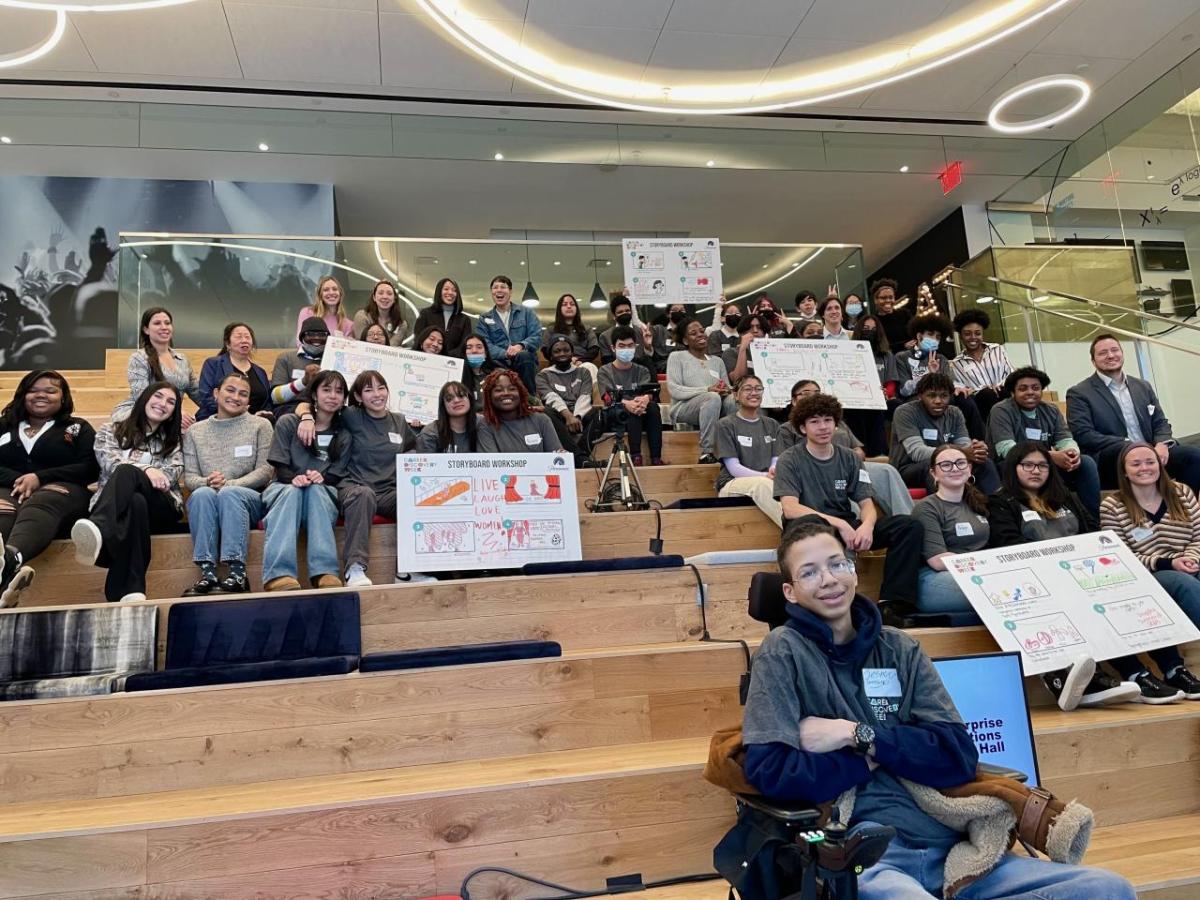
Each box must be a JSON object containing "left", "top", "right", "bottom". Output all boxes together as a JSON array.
[{"left": 166, "top": 593, "right": 362, "bottom": 678}]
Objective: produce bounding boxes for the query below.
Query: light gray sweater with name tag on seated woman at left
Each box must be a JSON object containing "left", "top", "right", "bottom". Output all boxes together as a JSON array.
[{"left": 184, "top": 413, "right": 274, "bottom": 491}]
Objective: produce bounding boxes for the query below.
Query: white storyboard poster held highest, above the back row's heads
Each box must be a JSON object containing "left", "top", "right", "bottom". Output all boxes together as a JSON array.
[{"left": 620, "top": 238, "right": 724, "bottom": 305}]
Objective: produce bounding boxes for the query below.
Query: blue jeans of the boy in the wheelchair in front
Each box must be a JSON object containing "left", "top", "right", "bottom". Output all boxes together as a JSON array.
[{"left": 858, "top": 839, "right": 1138, "bottom": 900}]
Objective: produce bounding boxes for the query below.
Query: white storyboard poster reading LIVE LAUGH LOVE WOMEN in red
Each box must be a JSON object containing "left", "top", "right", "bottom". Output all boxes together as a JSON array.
[{"left": 396, "top": 454, "right": 583, "bottom": 572}]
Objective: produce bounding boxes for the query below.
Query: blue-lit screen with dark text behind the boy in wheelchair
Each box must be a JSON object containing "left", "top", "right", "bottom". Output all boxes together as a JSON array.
[{"left": 934, "top": 653, "right": 1039, "bottom": 787}]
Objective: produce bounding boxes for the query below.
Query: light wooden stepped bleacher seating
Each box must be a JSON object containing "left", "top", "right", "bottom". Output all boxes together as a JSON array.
[{"left": 7, "top": 352, "right": 1200, "bottom": 900}]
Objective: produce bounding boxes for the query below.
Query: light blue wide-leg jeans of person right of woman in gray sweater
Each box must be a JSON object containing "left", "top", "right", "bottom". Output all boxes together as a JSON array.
[{"left": 263, "top": 481, "right": 338, "bottom": 583}]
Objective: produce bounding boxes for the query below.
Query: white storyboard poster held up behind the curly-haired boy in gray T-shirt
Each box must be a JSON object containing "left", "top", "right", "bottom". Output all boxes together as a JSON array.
[{"left": 750, "top": 337, "right": 888, "bottom": 409}]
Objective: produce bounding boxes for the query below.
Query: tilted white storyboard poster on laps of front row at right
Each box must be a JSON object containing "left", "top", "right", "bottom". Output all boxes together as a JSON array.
[{"left": 946, "top": 532, "right": 1200, "bottom": 674}]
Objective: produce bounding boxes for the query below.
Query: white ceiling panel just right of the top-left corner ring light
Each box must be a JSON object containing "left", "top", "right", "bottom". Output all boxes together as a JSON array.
[{"left": 71, "top": 0, "right": 242, "bottom": 78}]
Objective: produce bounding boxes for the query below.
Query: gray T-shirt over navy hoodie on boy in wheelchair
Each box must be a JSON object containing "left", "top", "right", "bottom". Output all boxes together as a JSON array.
[{"left": 742, "top": 625, "right": 962, "bottom": 847}]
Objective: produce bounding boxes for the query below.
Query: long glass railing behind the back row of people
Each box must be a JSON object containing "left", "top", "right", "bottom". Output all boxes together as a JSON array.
[{"left": 115, "top": 233, "right": 865, "bottom": 347}]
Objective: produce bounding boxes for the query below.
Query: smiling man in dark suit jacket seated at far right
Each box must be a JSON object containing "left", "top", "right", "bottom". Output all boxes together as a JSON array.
[{"left": 1067, "top": 335, "right": 1200, "bottom": 491}]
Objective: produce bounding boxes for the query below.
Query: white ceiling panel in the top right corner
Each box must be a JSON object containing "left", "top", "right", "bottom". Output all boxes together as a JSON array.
[{"left": 1037, "top": 0, "right": 1196, "bottom": 59}]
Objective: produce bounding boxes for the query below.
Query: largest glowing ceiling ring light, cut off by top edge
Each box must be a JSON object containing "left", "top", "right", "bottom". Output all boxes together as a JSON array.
[{"left": 415, "top": 0, "right": 1070, "bottom": 115}]
